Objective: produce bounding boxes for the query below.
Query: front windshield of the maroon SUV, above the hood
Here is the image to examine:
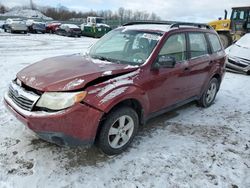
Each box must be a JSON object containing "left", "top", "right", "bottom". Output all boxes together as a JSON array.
[{"left": 89, "top": 28, "right": 162, "bottom": 65}]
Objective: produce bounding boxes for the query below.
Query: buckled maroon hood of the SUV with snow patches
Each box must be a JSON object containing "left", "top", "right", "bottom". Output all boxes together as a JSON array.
[{"left": 17, "top": 54, "right": 137, "bottom": 91}]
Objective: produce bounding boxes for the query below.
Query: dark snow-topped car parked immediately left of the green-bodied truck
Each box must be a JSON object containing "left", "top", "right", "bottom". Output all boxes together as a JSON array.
[{"left": 55, "top": 24, "right": 82, "bottom": 37}]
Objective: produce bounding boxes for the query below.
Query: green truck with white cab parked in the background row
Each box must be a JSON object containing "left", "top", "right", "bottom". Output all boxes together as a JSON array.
[{"left": 81, "top": 17, "right": 111, "bottom": 38}]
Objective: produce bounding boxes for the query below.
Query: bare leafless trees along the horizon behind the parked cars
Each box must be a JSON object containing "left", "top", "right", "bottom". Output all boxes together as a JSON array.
[{"left": 0, "top": 3, "right": 160, "bottom": 23}]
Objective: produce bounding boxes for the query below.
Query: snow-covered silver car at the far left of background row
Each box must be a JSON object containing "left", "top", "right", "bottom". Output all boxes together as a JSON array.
[{"left": 3, "top": 18, "right": 28, "bottom": 34}]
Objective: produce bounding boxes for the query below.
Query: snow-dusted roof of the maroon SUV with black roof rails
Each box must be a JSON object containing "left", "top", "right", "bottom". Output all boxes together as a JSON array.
[{"left": 123, "top": 21, "right": 213, "bottom": 32}]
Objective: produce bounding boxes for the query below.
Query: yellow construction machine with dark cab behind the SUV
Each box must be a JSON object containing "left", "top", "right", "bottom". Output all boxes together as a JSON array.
[{"left": 208, "top": 6, "right": 250, "bottom": 48}]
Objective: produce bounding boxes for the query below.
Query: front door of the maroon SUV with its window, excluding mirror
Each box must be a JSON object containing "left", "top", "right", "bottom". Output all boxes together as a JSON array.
[{"left": 144, "top": 33, "right": 188, "bottom": 112}]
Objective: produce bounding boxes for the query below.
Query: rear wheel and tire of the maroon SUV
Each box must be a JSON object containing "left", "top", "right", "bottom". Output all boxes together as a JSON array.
[{"left": 198, "top": 78, "right": 219, "bottom": 108}]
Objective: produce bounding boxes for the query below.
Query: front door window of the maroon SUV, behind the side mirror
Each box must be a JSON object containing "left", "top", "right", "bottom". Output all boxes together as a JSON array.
[{"left": 159, "top": 34, "right": 186, "bottom": 62}]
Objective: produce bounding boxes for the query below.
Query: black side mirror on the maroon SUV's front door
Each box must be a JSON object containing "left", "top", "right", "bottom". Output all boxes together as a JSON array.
[{"left": 154, "top": 55, "right": 176, "bottom": 69}]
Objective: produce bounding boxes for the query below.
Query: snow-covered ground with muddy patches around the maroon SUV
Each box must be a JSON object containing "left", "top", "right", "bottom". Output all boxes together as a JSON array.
[{"left": 0, "top": 33, "right": 250, "bottom": 188}]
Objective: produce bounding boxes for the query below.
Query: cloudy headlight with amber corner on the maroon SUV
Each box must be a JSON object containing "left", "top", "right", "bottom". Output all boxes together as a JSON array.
[{"left": 36, "top": 91, "right": 87, "bottom": 110}]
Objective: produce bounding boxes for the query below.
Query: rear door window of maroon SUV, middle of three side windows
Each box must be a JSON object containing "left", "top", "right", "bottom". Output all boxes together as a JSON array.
[{"left": 188, "top": 33, "right": 208, "bottom": 58}]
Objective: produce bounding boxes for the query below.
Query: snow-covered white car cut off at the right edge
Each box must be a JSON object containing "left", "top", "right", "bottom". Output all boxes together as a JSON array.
[{"left": 225, "top": 33, "right": 250, "bottom": 75}]
